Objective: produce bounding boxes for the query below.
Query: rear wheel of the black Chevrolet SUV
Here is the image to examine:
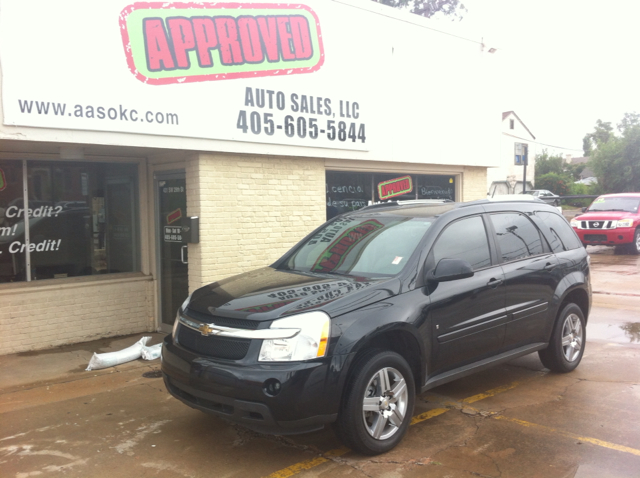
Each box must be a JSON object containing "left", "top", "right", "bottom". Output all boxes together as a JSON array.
[{"left": 538, "top": 304, "right": 587, "bottom": 373}]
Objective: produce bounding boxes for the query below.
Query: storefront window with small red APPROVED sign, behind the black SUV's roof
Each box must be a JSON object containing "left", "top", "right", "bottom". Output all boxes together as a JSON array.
[{"left": 326, "top": 171, "right": 456, "bottom": 219}]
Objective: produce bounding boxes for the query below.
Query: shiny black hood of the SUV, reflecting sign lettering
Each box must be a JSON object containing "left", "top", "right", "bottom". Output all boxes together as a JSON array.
[{"left": 188, "top": 267, "right": 400, "bottom": 321}]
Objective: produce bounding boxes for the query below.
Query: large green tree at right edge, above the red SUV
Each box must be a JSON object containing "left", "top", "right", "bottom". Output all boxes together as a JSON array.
[{"left": 585, "top": 113, "right": 640, "bottom": 193}]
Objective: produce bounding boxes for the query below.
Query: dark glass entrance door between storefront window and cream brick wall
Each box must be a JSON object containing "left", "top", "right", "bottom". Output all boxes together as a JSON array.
[{"left": 155, "top": 172, "right": 189, "bottom": 331}]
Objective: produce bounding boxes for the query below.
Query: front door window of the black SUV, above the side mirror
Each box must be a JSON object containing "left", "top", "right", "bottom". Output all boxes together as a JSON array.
[{"left": 433, "top": 216, "right": 491, "bottom": 270}]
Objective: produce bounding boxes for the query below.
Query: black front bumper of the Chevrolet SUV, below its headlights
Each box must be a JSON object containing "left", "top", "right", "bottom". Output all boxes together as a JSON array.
[{"left": 162, "top": 335, "right": 342, "bottom": 435}]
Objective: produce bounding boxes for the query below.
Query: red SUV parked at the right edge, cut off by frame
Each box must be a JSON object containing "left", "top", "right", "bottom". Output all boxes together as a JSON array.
[{"left": 571, "top": 193, "right": 640, "bottom": 254}]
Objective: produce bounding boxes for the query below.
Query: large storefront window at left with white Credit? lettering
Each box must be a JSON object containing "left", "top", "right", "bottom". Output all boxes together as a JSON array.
[{"left": 0, "top": 160, "right": 140, "bottom": 283}]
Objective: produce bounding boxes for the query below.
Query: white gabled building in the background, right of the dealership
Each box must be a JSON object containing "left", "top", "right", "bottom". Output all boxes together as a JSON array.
[{"left": 487, "top": 111, "right": 539, "bottom": 196}]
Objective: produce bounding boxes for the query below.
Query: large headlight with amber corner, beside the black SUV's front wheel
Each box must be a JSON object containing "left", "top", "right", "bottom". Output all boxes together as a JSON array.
[{"left": 258, "top": 311, "right": 330, "bottom": 362}]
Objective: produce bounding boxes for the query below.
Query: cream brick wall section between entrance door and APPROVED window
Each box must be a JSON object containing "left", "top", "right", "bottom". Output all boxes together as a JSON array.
[{"left": 186, "top": 154, "right": 326, "bottom": 292}]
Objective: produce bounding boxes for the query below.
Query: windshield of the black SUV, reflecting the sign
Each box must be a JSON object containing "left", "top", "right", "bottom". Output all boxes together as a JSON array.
[{"left": 280, "top": 216, "right": 434, "bottom": 276}]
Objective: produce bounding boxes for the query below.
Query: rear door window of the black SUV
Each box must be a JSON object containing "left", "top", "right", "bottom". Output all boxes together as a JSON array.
[{"left": 491, "top": 213, "right": 544, "bottom": 262}]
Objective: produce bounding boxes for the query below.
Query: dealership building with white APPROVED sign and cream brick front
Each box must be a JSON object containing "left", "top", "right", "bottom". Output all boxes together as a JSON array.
[{"left": 0, "top": 0, "right": 501, "bottom": 355}]
